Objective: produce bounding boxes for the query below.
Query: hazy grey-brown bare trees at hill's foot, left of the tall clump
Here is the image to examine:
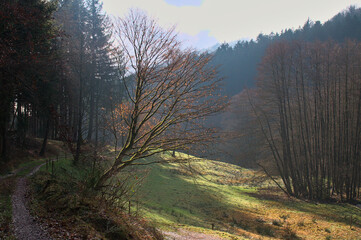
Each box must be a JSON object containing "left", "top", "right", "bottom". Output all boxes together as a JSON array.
[{"left": 218, "top": 89, "right": 271, "bottom": 168}]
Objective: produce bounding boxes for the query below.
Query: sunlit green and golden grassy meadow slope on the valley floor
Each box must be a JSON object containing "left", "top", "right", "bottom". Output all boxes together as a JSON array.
[{"left": 134, "top": 155, "right": 361, "bottom": 239}]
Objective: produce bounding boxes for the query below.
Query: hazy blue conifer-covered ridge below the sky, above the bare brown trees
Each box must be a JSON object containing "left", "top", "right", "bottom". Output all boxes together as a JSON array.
[{"left": 213, "top": 6, "right": 361, "bottom": 96}]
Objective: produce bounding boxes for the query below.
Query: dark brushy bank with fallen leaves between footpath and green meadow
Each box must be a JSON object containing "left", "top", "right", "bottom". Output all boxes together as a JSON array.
[{"left": 31, "top": 160, "right": 163, "bottom": 240}]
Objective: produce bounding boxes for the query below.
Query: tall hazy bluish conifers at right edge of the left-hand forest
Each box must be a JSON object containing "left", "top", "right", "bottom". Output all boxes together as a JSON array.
[{"left": 48, "top": 0, "right": 121, "bottom": 164}]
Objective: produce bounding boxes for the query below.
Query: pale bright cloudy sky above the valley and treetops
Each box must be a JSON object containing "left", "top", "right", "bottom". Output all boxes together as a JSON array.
[{"left": 103, "top": 0, "right": 361, "bottom": 49}]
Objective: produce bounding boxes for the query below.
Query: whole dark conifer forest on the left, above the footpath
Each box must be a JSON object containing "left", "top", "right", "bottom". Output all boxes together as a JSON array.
[{"left": 0, "top": 0, "right": 122, "bottom": 166}]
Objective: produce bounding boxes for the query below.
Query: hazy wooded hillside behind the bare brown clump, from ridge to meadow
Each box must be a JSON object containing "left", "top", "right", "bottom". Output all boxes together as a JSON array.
[{"left": 217, "top": 7, "right": 361, "bottom": 167}]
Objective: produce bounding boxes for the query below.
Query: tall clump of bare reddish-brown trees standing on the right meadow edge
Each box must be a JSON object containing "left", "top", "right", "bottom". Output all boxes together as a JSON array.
[{"left": 256, "top": 41, "right": 361, "bottom": 201}]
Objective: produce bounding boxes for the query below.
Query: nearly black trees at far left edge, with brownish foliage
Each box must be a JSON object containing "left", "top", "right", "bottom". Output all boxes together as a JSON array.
[{"left": 0, "top": 0, "right": 57, "bottom": 160}]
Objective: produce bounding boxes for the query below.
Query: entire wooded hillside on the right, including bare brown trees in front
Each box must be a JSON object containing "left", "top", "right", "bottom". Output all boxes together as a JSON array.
[{"left": 221, "top": 7, "right": 361, "bottom": 201}]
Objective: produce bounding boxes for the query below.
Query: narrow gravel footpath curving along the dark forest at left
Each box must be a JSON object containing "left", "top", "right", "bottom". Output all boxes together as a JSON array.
[{"left": 11, "top": 163, "right": 51, "bottom": 240}]
